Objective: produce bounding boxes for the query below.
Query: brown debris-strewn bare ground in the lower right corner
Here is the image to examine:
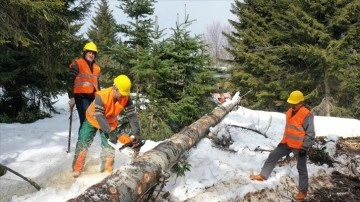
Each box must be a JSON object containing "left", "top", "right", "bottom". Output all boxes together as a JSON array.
[{"left": 239, "top": 137, "right": 360, "bottom": 202}]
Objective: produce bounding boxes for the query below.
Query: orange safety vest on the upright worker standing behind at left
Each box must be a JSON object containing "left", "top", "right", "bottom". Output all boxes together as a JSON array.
[{"left": 70, "top": 58, "right": 101, "bottom": 94}]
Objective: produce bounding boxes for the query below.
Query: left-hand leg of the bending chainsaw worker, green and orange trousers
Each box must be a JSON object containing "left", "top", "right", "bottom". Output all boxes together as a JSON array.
[{"left": 72, "top": 120, "right": 97, "bottom": 177}]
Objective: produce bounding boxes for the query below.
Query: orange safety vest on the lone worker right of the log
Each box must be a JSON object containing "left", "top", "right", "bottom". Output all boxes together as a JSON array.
[{"left": 281, "top": 106, "right": 310, "bottom": 149}]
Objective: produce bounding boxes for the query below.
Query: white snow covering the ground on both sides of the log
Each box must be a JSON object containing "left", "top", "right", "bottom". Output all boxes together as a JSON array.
[{"left": 0, "top": 94, "right": 360, "bottom": 202}]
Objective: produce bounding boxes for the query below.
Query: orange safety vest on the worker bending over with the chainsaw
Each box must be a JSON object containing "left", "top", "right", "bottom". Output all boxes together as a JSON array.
[{"left": 86, "top": 87, "right": 129, "bottom": 130}]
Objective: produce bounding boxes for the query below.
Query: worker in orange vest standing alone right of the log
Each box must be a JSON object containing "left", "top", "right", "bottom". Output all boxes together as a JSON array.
[{"left": 250, "top": 90, "right": 315, "bottom": 200}]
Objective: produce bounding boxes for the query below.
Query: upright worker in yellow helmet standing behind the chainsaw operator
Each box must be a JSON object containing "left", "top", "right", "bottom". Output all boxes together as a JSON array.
[{"left": 67, "top": 42, "right": 101, "bottom": 129}]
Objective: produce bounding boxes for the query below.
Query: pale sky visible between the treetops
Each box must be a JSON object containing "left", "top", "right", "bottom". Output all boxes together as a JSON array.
[{"left": 80, "top": 0, "right": 235, "bottom": 34}]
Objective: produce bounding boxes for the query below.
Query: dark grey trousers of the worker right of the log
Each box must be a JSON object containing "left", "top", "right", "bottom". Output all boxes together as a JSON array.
[{"left": 260, "top": 144, "right": 309, "bottom": 192}]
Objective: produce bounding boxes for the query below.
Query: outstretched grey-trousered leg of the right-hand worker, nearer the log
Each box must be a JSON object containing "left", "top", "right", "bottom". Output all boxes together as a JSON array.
[{"left": 260, "top": 144, "right": 291, "bottom": 179}]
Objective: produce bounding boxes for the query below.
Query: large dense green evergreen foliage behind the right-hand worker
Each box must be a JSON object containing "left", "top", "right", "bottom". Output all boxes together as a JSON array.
[{"left": 226, "top": 0, "right": 360, "bottom": 117}]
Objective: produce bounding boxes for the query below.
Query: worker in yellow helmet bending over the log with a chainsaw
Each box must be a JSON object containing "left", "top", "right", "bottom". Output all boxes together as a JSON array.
[{"left": 72, "top": 75, "right": 142, "bottom": 177}]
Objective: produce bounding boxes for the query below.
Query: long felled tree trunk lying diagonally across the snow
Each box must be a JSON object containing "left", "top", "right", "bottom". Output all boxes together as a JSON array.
[{"left": 69, "top": 93, "right": 240, "bottom": 202}]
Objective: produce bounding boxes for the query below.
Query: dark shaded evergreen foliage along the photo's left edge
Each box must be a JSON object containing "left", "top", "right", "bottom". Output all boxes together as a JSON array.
[{"left": 0, "top": 0, "right": 91, "bottom": 122}]
